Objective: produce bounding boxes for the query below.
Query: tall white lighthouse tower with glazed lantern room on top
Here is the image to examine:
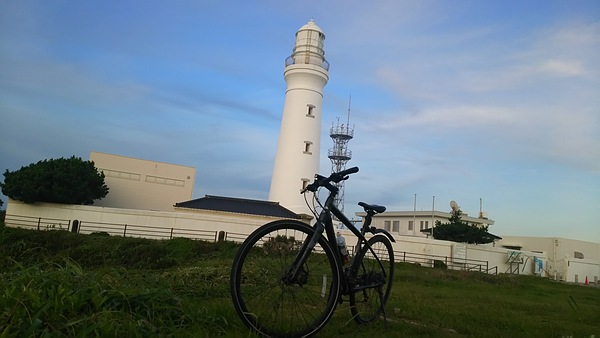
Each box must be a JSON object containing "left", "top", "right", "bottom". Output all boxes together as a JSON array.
[{"left": 269, "top": 19, "right": 329, "bottom": 215}]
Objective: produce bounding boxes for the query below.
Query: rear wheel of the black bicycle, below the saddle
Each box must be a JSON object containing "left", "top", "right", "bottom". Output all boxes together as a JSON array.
[{"left": 350, "top": 235, "right": 394, "bottom": 324}]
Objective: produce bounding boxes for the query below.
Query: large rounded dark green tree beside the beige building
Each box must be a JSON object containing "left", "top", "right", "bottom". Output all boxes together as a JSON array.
[{"left": 0, "top": 156, "right": 108, "bottom": 204}]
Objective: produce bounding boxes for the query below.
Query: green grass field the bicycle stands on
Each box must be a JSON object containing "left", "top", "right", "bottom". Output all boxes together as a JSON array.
[{"left": 0, "top": 227, "right": 600, "bottom": 337}]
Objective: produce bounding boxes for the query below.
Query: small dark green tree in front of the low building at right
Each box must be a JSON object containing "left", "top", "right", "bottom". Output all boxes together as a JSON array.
[{"left": 433, "top": 208, "right": 495, "bottom": 244}]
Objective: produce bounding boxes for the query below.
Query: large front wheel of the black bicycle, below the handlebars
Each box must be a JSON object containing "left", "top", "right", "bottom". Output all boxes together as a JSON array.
[{"left": 230, "top": 220, "right": 341, "bottom": 337}]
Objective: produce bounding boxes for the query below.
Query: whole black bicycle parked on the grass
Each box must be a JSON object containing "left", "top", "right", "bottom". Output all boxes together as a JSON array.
[{"left": 230, "top": 167, "right": 395, "bottom": 337}]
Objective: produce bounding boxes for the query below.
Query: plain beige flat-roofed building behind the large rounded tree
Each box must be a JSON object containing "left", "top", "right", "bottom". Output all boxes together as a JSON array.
[{"left": 90, "top": 152, "right": 196, "bottom": 211}]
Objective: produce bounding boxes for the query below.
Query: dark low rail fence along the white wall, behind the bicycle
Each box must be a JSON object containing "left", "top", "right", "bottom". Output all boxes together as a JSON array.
[{"left": 5, "top": 215, "right": 498, "bottom": 274}]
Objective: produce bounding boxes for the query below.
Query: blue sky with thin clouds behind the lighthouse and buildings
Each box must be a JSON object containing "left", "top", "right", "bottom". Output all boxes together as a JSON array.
[{"left": 0, "top": 0, "right": 600, "bottom": 242}]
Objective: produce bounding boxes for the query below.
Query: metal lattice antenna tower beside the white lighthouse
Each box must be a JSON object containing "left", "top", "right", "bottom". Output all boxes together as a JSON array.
[{"left": 327, "top": 96, "right": 354, "bottom": 212}]
